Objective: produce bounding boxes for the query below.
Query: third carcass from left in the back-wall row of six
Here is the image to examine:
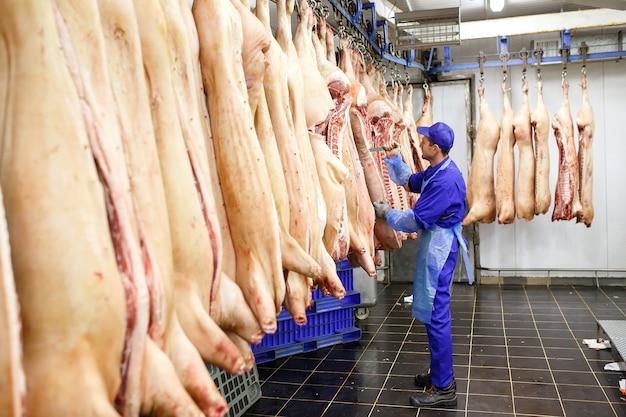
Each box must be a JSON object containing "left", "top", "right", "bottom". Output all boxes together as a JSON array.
[{"left": 513, "top": 81, "right": 535, "bottom": 220}]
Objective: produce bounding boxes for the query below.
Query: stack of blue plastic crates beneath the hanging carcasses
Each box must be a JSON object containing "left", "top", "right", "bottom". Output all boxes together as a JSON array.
[{"left": 252, "top": 261, "right": 361, "bottom": 364}]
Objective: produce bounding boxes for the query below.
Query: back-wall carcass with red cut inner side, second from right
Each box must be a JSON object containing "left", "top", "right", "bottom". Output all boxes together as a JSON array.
[{"left": 552, "top": 80, "right": 582, "bottom": 221}]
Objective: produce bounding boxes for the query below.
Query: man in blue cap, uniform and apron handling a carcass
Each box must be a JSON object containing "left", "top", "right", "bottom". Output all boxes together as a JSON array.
[{"left": 374, "top": 122, "right": 473, "bottom": 407}]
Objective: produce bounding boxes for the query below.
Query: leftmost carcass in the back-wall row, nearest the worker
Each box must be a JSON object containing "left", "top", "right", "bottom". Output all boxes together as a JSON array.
[{"left": 463, "top": 86, "right": 500, "bottom": 226}]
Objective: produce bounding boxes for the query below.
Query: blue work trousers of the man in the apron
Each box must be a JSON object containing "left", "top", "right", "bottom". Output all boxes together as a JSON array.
[{"left": 426, "top": 239, "right": 459, "bottom": 388}]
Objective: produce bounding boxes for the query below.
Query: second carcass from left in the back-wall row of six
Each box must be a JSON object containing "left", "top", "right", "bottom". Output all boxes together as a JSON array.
[{"left": 496, "top": 82, "right": 515, "bottom": 224}]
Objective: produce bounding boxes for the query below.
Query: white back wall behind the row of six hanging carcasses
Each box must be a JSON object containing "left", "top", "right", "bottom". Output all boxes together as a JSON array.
[{"left": 414, "top": 54, "right": 626, "bottom": 277}]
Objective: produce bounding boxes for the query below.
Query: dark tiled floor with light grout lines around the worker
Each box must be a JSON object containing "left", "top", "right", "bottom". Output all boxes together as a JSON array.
[{"left": 244, "top": 284, "right": 626, "bottom": 417}]
